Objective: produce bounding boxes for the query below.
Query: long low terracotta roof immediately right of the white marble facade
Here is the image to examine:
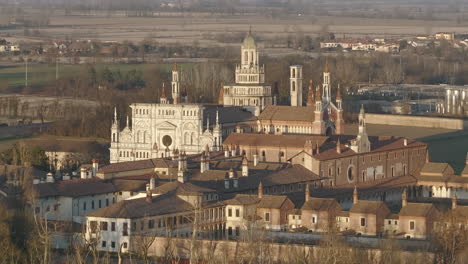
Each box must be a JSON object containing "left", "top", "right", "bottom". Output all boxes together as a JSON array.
[{"left": 223, "top": 133, "right": 328, "bottom": 149}]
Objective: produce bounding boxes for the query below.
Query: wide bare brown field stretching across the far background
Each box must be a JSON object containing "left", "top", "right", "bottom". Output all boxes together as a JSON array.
[{"left": 2, "top": 13, "right": 466, "bottom": 46}]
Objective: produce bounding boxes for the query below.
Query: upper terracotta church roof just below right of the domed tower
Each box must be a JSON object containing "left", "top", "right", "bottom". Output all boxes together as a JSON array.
[{"left": 258, "top": 105, "right": 315, "bottom": 122}]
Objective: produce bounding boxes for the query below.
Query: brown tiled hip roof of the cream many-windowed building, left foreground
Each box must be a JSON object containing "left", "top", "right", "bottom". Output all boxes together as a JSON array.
[{"left": 86, "top": 194, "right": 193, "bottom": 219}]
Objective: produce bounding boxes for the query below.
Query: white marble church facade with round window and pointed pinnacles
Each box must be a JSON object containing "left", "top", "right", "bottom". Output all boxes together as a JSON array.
[{"left": 110, "top": 67, "right": 222, "bottom": 163}]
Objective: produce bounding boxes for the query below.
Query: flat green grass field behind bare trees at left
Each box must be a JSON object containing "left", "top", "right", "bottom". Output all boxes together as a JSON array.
[{"left": 0, "top": 64, "right": 188, "bottom": 87}]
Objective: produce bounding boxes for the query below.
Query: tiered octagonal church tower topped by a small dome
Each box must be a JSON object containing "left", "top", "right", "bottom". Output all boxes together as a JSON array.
[{"left": 219, "top": 28, "right": 275, "bottom": 114}]
